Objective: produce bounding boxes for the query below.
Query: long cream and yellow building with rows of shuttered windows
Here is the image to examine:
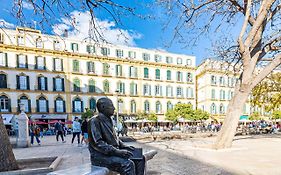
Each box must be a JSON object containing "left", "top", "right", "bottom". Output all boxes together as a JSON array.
[{"left": 0, "top": 28, "right": 196, "bottom": 123}]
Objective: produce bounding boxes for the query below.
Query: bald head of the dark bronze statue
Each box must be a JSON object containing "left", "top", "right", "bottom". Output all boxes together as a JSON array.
[{"left": 97, "top": 97, "right": 115, "bottom": 117}]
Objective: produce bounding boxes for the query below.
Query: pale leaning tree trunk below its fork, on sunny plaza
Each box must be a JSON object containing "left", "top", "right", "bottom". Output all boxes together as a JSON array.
[{"left": 213, "top": 85, "right": 249, "bottom": 149}]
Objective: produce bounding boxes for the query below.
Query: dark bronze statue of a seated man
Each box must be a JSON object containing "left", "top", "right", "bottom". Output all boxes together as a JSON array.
[{"left": 88, "top": 97, "right": 145, "bottom": 175}]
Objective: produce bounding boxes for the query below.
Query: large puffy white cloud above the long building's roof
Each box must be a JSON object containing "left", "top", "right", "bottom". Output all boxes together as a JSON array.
[{"left": 52, "top": 11, "right": 142, "bottom": 46}]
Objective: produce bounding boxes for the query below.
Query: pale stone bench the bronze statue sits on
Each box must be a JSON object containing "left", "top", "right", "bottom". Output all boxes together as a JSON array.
[{"left": 47, "top": 150, "right": 157, "bottom": 175}]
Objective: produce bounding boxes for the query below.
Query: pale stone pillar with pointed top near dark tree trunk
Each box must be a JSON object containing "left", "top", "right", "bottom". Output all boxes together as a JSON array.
[{"left": 17, "top": 104, "right": 30, "bottom": 148}]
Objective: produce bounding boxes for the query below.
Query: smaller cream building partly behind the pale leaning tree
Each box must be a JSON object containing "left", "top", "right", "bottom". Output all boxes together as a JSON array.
[{"left": 196, "top": 59, "right": 251, "bottom": 120}]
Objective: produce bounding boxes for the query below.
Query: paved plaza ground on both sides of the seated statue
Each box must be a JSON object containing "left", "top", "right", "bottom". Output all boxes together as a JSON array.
[{"left": 8, "top": 135, "right": 281, "bottom": 175}]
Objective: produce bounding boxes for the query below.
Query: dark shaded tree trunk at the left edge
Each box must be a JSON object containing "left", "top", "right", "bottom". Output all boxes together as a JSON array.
[{"left": 0, "top": 117, "right": 19, "bottom": 172}]
